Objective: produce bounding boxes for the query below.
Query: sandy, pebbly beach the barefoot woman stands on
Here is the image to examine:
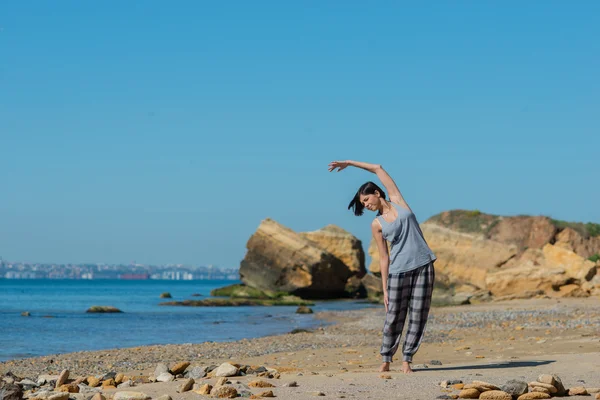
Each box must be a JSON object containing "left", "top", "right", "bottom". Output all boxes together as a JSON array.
[{"left": 0, "top": 297, "right": 600, "bottom": 400}]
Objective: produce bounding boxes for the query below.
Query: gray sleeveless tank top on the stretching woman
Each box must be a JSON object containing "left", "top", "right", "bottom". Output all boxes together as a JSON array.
[{"left": 377, "top": 202, "right": 436, "bottom": 274}]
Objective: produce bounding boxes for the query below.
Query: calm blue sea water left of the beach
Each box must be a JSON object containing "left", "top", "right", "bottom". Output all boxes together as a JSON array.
[{"left": 0, "top": 279, "right": 370, "bottom": 361}]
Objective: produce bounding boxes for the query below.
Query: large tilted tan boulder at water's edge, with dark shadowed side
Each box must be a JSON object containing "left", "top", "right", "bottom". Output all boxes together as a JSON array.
[{"left": 240, "top": 218, "right": 353, "bottom": 298}]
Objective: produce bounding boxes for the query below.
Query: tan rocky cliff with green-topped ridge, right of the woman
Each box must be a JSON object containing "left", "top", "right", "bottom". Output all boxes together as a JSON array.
[{"left": 421, "top": 210, "right": 600, "bottom": 298}]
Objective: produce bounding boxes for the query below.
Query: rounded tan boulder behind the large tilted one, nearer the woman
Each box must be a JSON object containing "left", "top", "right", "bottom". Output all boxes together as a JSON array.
[{"left": 300, "top": 225, "right": 367, "bottom": 278}]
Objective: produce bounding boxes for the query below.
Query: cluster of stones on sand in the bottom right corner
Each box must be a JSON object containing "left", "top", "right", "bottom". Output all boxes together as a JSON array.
[{"left": 438, "top": 374, "right": 600, "bottom": 400}]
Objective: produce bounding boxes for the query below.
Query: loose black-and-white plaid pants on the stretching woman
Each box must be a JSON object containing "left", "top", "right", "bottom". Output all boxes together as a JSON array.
[{"left": 380, "top": 262, "right": 435, "bottom": 362}]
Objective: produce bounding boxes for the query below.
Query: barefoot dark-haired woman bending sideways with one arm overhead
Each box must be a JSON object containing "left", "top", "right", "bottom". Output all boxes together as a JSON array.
[{"left": 329, "top": 161, "right": 436, "bottom": 374}]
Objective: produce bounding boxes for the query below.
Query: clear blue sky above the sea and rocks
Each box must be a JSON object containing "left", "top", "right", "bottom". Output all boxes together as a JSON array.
[{"left": 0, "top": 1, "right": 600, "bottom": 267}]
